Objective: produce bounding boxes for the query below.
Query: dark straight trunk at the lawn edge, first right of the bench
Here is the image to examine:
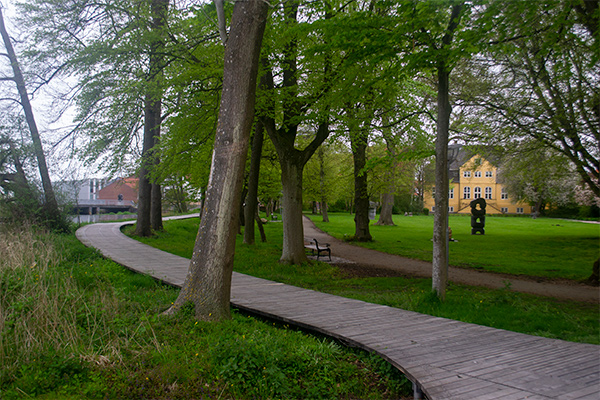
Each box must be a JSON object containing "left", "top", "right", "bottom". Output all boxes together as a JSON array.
[{"left": 350, "top": 126, "right": 373, "bottom": 242}]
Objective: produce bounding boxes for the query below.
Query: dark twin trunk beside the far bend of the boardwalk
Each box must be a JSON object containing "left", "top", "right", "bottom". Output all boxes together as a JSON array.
[{"left": 135, "top": 0, "right": 169, "bottom": 236}]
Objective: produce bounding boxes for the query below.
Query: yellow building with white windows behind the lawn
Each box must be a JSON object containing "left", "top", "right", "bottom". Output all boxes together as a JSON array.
[{"left": 423, "top": 145, "right": 532, "bottom": 214}]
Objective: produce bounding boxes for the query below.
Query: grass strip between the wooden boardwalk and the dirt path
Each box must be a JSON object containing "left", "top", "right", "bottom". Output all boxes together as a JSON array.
[{"left": 129, "top": 219, "right": 600, "bottom": 344}]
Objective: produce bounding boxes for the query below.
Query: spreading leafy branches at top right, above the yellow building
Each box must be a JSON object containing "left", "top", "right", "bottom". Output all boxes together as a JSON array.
[{"left": 467, "top": 0, "right": 600, "bottom": 197}]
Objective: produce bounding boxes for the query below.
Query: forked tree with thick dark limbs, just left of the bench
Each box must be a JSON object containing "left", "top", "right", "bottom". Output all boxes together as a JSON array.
[{"left": 260, "top": 0, "right": 331, "bottom": 264}]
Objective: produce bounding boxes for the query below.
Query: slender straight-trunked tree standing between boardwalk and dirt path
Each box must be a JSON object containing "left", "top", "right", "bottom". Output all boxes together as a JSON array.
[{"left": 390, "top": 0, "right": 480, "bottom": 299}]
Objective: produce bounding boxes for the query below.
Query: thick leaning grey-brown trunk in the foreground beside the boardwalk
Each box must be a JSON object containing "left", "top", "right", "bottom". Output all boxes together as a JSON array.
[{"left": 168, "top": 0, "right": 268, "bottom": 320}]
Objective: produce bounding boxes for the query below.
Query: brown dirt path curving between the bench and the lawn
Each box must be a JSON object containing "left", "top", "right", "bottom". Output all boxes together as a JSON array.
[{"left": 303, "top": 217, "right": 600, "bottom": 304}]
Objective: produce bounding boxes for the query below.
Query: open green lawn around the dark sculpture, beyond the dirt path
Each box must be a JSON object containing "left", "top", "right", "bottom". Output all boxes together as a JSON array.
[{"left": 308, "top": 213, "right": 600, "bottom": 281}]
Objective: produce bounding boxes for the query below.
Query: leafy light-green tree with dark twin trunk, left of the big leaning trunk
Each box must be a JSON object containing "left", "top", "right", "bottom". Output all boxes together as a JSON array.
[{"left": 21, "top": 0, "right": 222, "bottom": 228}]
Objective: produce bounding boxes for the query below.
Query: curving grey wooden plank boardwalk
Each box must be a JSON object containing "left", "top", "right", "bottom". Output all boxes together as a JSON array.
[{"left": 77, "top": 217, "right": 600, "bottom": 400}]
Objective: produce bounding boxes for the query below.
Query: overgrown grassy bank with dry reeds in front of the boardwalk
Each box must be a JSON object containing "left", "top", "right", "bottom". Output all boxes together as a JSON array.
[{"left": 0, "top": 230, "right": 408, "bottom": 400}]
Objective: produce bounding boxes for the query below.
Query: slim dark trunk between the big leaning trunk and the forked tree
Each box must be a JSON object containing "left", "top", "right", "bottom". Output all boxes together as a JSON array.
[{"left": 244, "top": 122, "right": 264, "bottom": 244}]
